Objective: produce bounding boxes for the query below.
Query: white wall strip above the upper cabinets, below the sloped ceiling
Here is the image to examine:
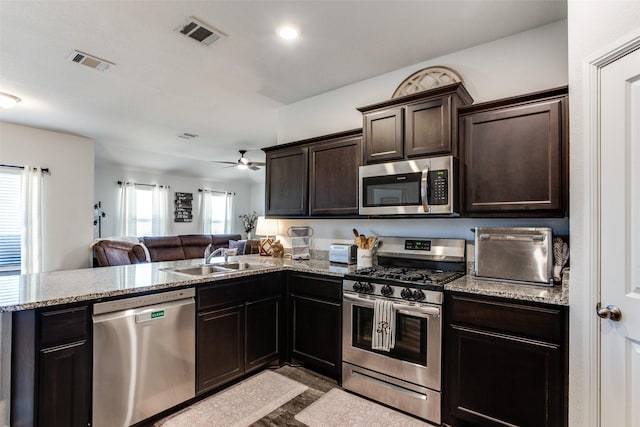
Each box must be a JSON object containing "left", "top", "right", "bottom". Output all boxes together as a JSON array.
[{"left": 278, "top": 21, "right": 567, "bottom": 144}]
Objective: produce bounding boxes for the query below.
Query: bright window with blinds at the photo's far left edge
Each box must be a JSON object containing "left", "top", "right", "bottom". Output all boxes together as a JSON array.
[{"left": 0, "top": 171, "right": 22, "bottom": 275}]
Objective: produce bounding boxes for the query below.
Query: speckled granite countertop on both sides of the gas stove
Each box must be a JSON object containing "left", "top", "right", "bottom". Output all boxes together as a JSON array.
[{"left": 0, "top": 255, "right": 568, "bottom": 312}]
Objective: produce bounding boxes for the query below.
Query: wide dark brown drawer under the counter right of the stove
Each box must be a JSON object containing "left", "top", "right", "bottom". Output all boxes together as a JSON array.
[{"left": 447, "top": 295, "right": 566, "bottom": 344}]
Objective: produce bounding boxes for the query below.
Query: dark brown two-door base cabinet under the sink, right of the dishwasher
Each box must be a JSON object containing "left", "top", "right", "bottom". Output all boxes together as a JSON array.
[{"left": 196, "top": 274, "right": 285, "bottom": 393}]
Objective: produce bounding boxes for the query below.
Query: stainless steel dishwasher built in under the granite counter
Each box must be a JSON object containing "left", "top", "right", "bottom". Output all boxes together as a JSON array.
[{"left": 93, "top": 288, "right": 195, "bottom": 427}]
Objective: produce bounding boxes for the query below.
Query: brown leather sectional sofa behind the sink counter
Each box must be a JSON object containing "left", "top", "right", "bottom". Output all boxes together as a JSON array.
[{"left": 93, "top": 234, "right": 259, "bottom": 267}]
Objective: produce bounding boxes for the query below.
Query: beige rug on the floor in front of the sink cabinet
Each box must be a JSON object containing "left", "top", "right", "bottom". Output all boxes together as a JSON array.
[{"left": 155, "top": 371, "right": 307, "bottom": 427}]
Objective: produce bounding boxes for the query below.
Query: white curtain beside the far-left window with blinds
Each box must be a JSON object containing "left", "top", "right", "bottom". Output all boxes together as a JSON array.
[{"left": 20, "top": 165, "right": 44, "bottom": 274}]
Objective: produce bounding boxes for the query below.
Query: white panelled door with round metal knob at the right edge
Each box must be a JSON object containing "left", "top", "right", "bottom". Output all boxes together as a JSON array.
[{"left": 598, "top": 45, "right": 640, "bottom": 427}]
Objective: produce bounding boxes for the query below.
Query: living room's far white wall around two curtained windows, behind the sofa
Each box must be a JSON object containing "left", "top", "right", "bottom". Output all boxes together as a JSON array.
[{"left": 95, "top": 163, "right": 264, "bottom": 238}]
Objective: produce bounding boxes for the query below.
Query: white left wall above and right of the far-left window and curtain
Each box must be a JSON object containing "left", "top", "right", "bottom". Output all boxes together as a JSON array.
[{"left": 0, "top": 122, "right": 94, "bottom": 271}]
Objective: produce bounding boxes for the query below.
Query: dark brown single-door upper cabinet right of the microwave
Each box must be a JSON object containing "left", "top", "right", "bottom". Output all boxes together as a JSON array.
[{"left": 459, "top": 88, "right": 568, "bottom": 217}]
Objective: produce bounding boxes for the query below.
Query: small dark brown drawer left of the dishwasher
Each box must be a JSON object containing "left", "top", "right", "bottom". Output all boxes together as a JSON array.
[{"left": 40, "top": 306, "right": 89, "bottom": 348}]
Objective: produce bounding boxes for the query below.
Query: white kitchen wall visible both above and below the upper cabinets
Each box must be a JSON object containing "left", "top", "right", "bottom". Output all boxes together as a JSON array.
[{"left": 278, "top": 21, "right": 569, "bottom": 247}]
